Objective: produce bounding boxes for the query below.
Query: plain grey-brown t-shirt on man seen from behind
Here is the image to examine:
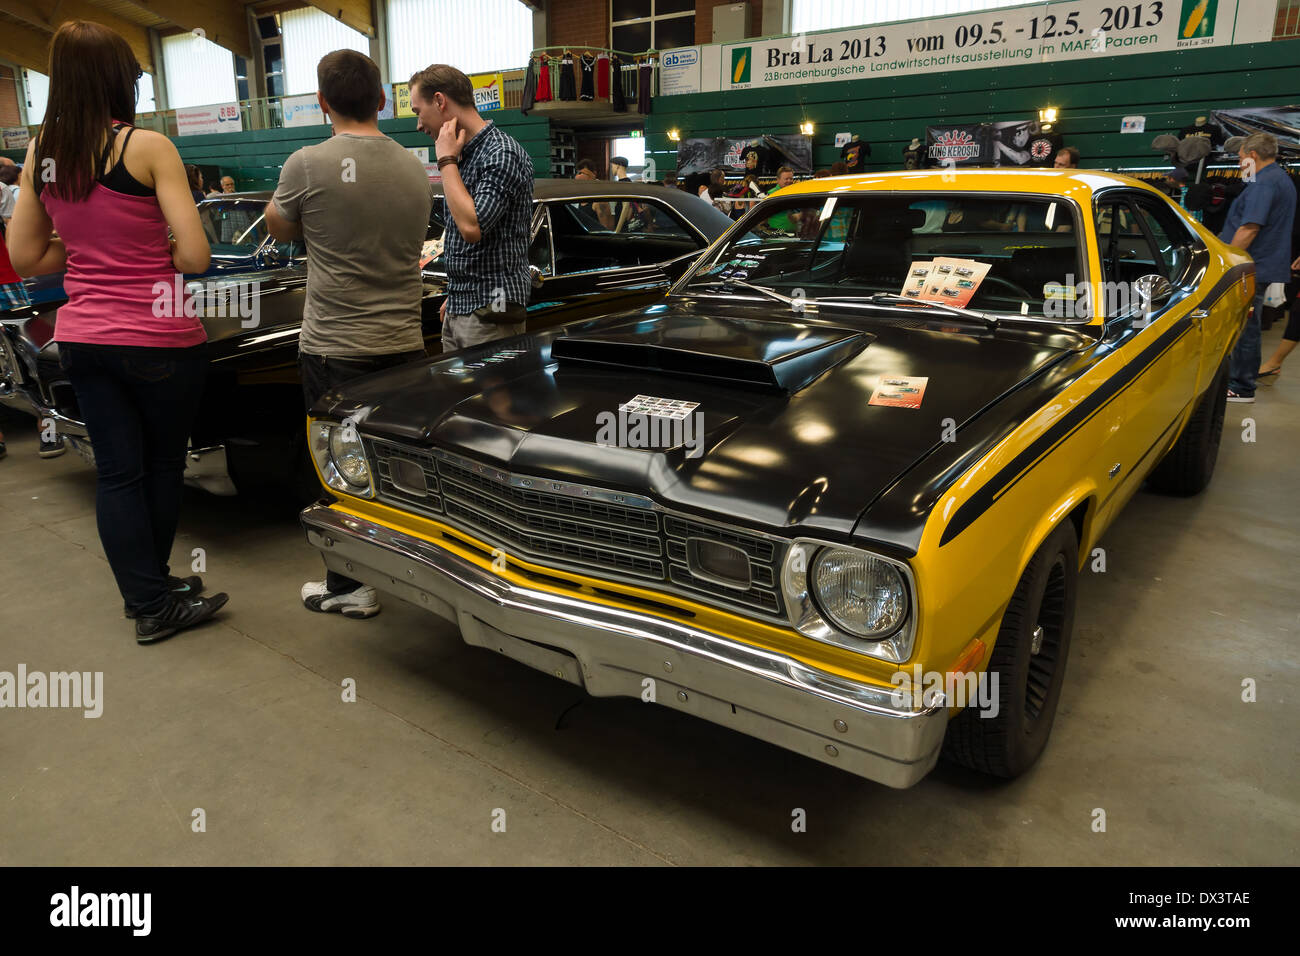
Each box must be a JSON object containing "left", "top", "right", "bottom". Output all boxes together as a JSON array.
[{"left": 274, "top": 133, "right": 430, "bottom": 355}]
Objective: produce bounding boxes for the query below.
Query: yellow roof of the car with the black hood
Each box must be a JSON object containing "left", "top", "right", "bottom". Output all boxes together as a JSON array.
[{"left": 780, "top": 169, "right": 1158, "bottom": 200}]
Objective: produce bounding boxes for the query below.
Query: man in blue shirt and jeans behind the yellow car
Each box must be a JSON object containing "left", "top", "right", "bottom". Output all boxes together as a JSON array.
[{"left": 1219, "top": 133, "right": 1296, "bottom": 405}]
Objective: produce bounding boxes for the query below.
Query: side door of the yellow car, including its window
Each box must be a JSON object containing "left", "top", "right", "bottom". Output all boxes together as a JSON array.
[{"left": 1096, "top": 190, "right": 1205, "bottom": 502}]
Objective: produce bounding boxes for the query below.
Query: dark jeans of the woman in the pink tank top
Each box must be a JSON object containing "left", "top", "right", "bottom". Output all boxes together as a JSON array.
[{"left": 59, "top": 342, "right": 208, "bottom": 615}]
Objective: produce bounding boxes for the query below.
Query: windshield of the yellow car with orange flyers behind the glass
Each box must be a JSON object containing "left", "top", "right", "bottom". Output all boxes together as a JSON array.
[{"left": 677, "top": 193, "right": 1084, "bottom": 319}]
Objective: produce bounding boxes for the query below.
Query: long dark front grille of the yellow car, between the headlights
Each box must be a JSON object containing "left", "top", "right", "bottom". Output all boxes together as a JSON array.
[{"left": 367, "top": 438, "right": 785, "bottom": 622}]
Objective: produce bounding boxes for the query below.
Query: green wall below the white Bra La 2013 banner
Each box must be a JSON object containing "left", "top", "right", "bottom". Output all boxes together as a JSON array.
[{"left": 646, "top": 40, "right": 1300, "bottom": 170}]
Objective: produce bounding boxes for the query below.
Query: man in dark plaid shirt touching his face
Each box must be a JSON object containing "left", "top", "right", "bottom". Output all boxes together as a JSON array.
[{"left": 411, "top": 64, "right": 533, "bottom": 352}]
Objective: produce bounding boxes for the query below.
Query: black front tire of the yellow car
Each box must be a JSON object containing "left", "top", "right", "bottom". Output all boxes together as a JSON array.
[{"left": 944, "top": 519, "right": 1079, "bottom": 778}]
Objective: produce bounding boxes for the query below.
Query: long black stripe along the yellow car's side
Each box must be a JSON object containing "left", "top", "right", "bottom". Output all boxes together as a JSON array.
[{"left": 939, "top": 264, "right": 1255, "bottom": 548}]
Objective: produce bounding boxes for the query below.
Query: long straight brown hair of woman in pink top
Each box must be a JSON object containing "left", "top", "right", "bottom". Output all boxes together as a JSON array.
[{"left": 33, "top": 20, "right": 142, "bottom": 202}]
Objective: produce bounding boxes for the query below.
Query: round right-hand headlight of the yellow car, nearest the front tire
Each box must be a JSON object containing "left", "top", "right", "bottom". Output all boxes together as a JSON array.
[{"left": 811, "top": 548, "right": 907, "bottom": 640}]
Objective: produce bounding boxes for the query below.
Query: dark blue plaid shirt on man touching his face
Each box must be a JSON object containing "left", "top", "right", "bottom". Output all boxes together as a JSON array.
[{"left": 442, "top": 122, "right": 533, "bottom": 315}]
